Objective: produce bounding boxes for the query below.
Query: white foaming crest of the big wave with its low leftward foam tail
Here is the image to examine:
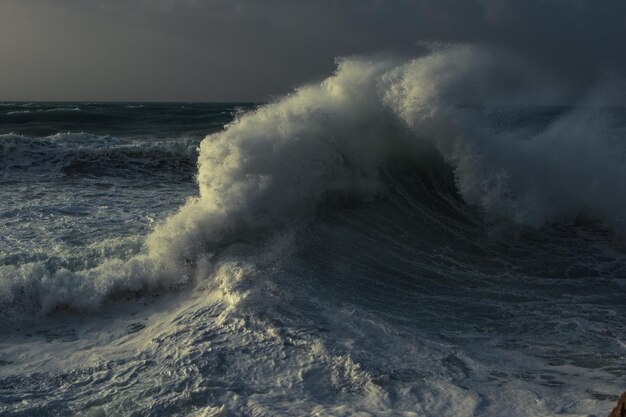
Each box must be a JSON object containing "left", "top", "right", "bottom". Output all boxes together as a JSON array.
[{"left": 0, "top": 46, "right": 626, "bottom": 317}]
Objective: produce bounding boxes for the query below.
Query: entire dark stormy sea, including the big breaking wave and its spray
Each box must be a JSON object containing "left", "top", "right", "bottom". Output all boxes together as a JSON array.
[{"left": 0, "top": 47, "right": 626, "bottom": 417}]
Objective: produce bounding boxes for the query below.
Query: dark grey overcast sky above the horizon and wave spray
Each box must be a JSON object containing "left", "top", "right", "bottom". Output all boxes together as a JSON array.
[{"left": 0, "top": 0, "right": 626, "bottom": 101}]
